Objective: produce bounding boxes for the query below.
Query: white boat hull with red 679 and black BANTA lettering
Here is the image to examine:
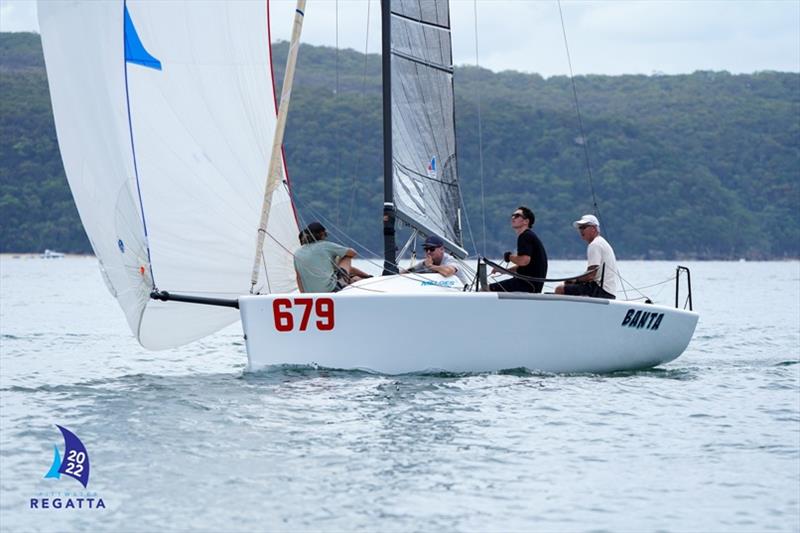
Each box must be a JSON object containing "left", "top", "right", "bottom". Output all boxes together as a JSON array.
[{"left": 239, "top": 275, "right": 698, "bottom": 374}]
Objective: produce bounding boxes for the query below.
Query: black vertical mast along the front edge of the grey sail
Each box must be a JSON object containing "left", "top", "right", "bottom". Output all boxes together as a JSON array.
[{"left": 381, "top": 0, "right": 397, "bottom": 275}]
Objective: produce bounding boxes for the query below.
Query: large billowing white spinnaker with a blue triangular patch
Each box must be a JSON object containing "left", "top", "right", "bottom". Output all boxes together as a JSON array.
[{"left": 39, "top": 0, "right": 298, "bottom": 348}]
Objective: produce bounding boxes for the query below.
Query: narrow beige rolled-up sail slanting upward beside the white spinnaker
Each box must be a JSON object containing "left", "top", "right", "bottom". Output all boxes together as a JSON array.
[{"left": 250, "top": 0, "right": 306, "bottom": 294}]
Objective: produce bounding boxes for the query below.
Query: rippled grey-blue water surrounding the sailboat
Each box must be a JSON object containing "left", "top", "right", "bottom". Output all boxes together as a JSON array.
[{"left": 0, "top": 257, "right": 800, "bottom": 531}]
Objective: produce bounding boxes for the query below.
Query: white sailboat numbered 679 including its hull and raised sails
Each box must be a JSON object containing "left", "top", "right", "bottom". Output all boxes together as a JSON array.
[{"left": 39, "top": 0, "right": 698, "bottom": 374}]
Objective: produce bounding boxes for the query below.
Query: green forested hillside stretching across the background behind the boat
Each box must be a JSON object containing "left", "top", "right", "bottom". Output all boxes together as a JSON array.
[{"left": 0, "top": 33, "right": 800, "bottom": 259}]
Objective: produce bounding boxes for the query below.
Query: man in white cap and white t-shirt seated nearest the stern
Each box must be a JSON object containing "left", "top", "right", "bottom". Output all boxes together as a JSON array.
[{"left": 556, "top": 215, "right": 617, "bottom": 300}]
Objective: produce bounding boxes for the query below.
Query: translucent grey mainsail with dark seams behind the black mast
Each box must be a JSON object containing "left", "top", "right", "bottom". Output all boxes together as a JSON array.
[{"left": 391, "top": 0, "right": 466, "bottom": 257}]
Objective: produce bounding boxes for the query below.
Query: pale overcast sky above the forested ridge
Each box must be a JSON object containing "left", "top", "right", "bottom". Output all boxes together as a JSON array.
[{"left": 0, "top": 0, "right": 800, "bottom": 76}]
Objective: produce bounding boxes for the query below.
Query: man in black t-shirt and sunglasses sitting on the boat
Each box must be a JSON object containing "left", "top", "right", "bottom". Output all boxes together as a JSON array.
[{"left": 489, "top": 206, "right": 547, "bottom": 292}]
